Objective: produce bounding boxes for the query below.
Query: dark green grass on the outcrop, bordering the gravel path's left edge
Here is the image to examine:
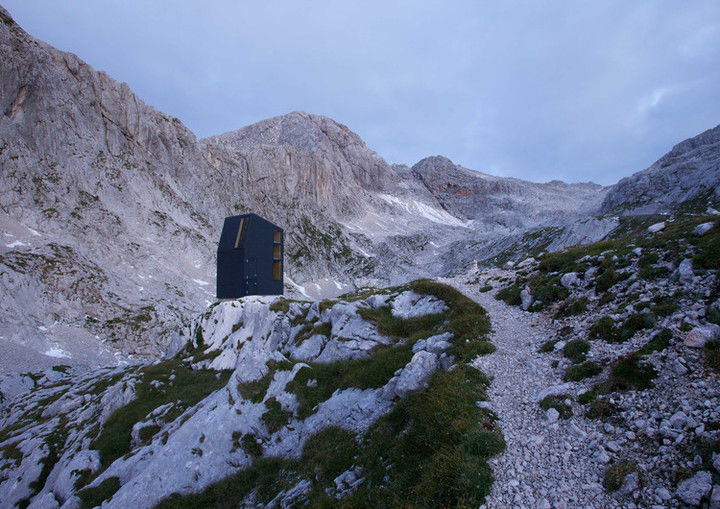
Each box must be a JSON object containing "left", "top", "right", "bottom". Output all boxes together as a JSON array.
[{"left": 159, "top": 281, "right": 505, "bottom": 508}]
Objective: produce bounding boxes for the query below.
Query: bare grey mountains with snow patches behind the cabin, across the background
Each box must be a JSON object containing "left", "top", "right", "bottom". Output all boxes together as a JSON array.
[{"left": 0, "top": 8, "right": 720, "bottom": 370}]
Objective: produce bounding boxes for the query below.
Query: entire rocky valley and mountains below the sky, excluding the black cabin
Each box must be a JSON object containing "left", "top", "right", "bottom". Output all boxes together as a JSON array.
[{"left": 0, "top": 7, "right": 720, "bottom": 508}]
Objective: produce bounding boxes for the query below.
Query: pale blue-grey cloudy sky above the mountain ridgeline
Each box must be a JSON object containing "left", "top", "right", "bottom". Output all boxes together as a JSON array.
[{"left": 5, "top": 0, "right": 720, "bottom": 184}]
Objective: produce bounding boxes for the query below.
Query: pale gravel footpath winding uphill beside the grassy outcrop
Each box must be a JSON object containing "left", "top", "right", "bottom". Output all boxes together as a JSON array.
[{"left": 443, "top": 277, "right": 620, "bottom": 509}]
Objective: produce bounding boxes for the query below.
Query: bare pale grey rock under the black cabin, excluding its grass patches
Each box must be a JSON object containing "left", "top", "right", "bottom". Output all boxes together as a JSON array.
[{"left": 0, "top": 291, "right": 462, "bottom": 508}]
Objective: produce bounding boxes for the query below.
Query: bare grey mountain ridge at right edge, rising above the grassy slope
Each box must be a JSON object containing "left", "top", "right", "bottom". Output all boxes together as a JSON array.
[{"left": 602, "top": 126, "right": 720, "bottom": 214}]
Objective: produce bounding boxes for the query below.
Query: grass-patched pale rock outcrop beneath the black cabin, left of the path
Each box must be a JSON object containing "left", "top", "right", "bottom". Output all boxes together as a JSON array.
[{"left": 0, "top": 281, "right": 504, "bottom": 507}]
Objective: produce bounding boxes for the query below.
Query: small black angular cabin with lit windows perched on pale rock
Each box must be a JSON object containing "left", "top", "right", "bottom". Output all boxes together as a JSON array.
[{"left": 217, "top": 214, "right": 283, "bottom": 299}]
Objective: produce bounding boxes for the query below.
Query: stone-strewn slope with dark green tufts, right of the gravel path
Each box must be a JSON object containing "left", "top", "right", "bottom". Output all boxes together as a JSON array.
[{"left": 490, "top": 215, "right": 720, "bottom": 507}]
